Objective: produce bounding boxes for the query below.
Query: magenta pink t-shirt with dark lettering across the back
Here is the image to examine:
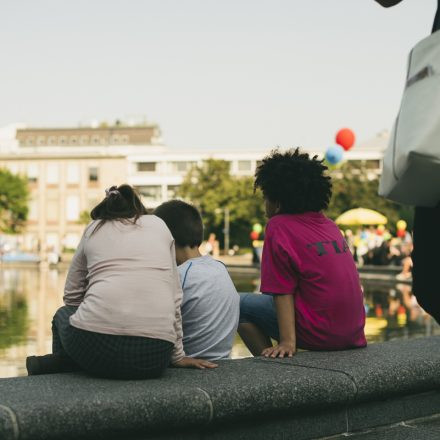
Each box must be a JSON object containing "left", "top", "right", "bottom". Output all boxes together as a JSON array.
[{"left": 261, "top": 212, "right": 367, "bottom": 350}]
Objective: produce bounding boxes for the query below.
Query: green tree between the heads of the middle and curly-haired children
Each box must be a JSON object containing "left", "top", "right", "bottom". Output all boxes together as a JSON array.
[{"left": 178, "top": 159, "right": 265, "bottom": 246}]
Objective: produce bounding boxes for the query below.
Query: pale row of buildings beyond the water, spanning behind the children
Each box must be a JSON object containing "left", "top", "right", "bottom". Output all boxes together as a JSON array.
[{"left": 0, "top": 125, "right": 387, "bottom": 254}]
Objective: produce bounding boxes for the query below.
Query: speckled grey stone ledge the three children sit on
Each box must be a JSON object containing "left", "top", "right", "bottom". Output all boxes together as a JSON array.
[{"left": 0, "top": 336, "right": 440, "bottom": 440}]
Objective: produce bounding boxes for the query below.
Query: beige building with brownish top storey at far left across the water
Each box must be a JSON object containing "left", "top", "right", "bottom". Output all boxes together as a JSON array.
[{"left": 0, "top": 126, "right": 163, "bottom": 254}]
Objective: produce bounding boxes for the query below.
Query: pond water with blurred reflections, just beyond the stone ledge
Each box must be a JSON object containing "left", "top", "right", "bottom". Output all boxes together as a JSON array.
[{"left": 0, "top": 268, "right": 440, "bottom": 377}]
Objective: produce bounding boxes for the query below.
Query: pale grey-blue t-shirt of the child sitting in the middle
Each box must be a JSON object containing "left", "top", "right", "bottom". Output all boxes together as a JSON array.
[{"left": 178, "top": 255, "right": 240, "bottom": 360}]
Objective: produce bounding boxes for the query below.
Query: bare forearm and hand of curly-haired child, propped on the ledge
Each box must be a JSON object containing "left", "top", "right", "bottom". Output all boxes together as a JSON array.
[{"left": 262, "top": 295, "right": 296, "bottom": 358}]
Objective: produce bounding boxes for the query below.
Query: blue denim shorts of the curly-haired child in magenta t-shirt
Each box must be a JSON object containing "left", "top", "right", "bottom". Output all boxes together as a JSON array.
[{"left": 240, "top": 293, "right": 280, "bottom": 341}]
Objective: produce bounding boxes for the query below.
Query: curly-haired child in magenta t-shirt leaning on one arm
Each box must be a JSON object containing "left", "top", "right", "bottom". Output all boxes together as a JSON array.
[{"left": 239, "top": 148, "right": 367, "bottom": 357}]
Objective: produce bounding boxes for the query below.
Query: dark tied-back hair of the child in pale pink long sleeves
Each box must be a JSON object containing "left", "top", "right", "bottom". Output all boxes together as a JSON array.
[{"left": 90, "top": 184, "right": 147, "bottom": 232}]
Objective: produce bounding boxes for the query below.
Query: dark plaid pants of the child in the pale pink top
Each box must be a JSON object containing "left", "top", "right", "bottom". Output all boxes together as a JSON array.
[{"left": 52, "top": 306, "right": 174, "bottom": 379}]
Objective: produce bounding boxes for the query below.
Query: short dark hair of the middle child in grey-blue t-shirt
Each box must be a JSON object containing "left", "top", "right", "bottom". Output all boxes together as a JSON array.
[{"left": 153, "top": 200, "right": 203, "bottom": 247}]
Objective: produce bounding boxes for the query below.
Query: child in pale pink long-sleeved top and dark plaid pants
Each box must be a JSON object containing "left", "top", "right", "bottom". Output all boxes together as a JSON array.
[{"left": 26, "top": 185, "right": 216, "bottom": 379}]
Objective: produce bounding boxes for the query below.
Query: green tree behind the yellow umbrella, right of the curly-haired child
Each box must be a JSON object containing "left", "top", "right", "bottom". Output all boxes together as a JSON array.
[{"left": 326, "top": 161, "right": 412, "bottom": 233}]
